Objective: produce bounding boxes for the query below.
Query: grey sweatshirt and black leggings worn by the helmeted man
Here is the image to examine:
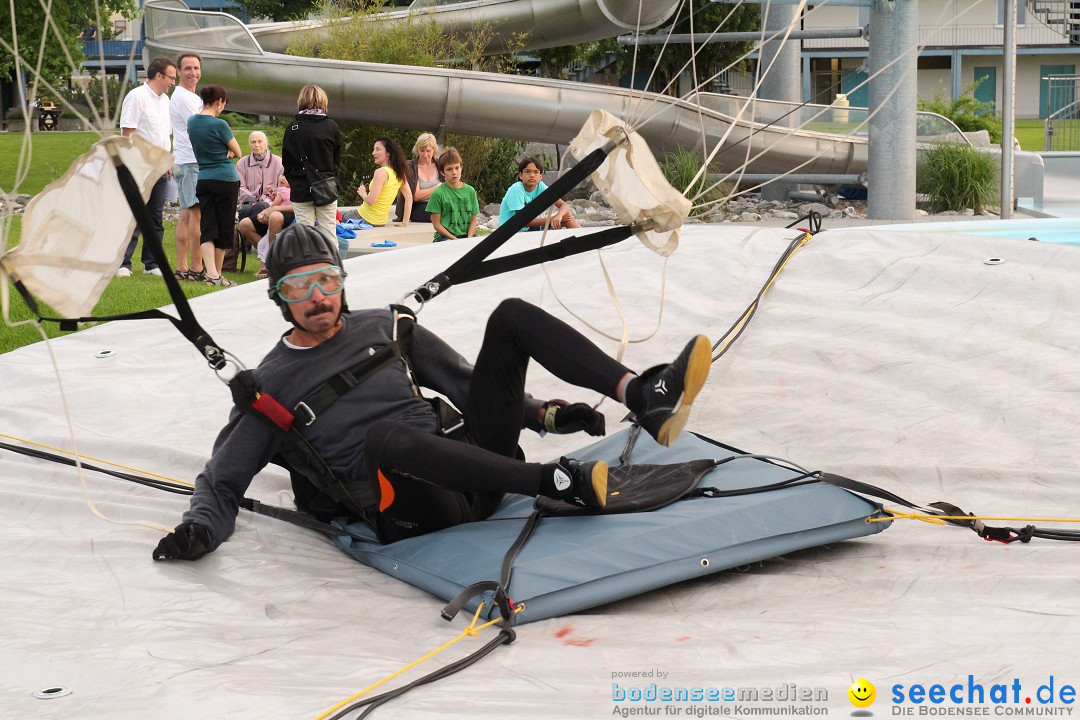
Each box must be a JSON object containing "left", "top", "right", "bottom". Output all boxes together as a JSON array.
[{"left": 184, "top": 300, "right": 627, "bottom": 549}]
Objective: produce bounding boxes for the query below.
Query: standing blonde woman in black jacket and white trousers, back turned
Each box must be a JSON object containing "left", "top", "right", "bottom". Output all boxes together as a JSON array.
[{"left": 281, "top": 85, "right": 341, "bottom": 243}]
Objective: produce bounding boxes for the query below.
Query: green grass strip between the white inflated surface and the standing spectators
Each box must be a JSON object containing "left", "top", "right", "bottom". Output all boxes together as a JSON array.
[{"left": 0, "top": 217, "right": 259, "bottom": 353}]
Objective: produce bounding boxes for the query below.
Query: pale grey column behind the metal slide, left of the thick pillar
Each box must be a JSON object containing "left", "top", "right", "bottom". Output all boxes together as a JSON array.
[{"left": 758, "top": 3, "right": 802, "bottom": 200}]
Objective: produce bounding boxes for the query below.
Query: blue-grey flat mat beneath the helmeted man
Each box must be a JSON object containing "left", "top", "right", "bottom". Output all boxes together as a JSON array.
[{"left": 335, "top": 431, "right": 889, "bottom": 623}]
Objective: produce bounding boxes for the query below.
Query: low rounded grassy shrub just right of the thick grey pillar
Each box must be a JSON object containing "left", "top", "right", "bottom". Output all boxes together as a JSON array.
[{"left": 916, "top": 144, "right": 998, "bottom": 213}]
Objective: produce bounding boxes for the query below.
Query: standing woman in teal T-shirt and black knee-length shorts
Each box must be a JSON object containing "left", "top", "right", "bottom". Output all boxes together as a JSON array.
[{"left": 188, "top": 85, "right": 241, "bottom": 286}]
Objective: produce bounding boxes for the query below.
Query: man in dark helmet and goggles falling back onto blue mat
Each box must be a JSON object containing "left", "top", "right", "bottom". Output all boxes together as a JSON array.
[{"left": 153, "top": 226, "right": 712, "bottom": 560}]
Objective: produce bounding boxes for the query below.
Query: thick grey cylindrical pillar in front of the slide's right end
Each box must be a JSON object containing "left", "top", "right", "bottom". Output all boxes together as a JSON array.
[{"left": 866, "top": 0, "right": 919, "bottom": 220}]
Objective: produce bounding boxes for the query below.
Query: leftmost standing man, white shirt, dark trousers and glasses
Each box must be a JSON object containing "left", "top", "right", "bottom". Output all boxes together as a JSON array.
[{"left": 117, "top": 57, "right": 176, "bottom": 277}]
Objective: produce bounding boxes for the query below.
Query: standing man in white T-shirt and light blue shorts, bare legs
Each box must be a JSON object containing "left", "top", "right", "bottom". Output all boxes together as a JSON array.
[{"left": 168, "top": 52, "right": 203, "bottom": 281}]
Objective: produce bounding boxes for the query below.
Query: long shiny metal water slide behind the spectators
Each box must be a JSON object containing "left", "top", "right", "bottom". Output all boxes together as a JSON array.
[{"left": 144, "top": 0, "right": 867, "bottom": 175}]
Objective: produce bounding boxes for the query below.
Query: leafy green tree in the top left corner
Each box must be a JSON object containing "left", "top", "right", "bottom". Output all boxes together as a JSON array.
[{"left": 0, "top": 0, "right": 138, "bottom": 89}]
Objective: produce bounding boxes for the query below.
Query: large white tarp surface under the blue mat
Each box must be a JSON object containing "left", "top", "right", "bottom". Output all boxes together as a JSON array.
[{"left": 0, "top": 226, "right": 1080, "bottom": 720}]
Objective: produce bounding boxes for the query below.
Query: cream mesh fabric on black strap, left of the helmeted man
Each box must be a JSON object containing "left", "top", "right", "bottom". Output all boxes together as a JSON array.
[{"left": 0, "top": 135, "right": 173, "bottom": 317}]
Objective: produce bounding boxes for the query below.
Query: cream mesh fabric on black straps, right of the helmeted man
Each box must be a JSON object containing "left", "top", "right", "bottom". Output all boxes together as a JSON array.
[{"left": 570, "top": 105, "right": 691, "bottom": 256}]
